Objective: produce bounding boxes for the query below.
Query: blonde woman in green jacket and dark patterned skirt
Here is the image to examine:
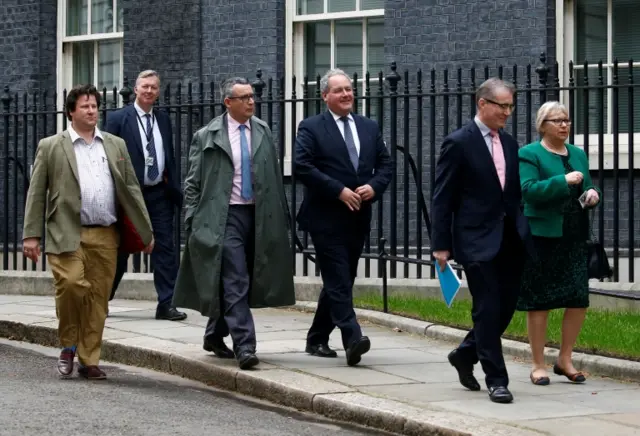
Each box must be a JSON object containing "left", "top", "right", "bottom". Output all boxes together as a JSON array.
[{"left": 517, "top": 101, "right": 600, "bottom": 385}]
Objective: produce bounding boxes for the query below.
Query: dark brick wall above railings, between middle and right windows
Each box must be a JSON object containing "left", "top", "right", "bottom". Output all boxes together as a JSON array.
[{"left": 385, "top": 0, "right": 555, "bottom": 71}]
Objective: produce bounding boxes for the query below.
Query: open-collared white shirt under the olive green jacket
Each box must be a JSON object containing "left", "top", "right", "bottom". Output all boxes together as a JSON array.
[{"left": 68, "top": 126, "right": 117, "bottom": 226}]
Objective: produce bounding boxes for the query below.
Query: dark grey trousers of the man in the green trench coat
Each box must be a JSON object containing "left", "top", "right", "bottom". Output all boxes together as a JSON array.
[{"left": 204, "top": 205, "right": 256, "bottom": 355}]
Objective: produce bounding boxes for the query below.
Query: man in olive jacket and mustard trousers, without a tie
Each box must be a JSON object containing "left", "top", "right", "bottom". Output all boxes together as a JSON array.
[{"left": 23, "top": 85, "right": 153, "bottom": 380}]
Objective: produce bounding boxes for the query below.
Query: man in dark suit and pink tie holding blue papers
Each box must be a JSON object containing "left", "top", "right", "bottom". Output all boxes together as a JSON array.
[{"left": 431, "top": 78, "right": 533, "bottom": 403}]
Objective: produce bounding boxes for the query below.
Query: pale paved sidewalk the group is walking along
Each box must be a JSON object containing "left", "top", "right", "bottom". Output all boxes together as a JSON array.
[{"left": 0, "top": 295, "right": 640, "bottom": 436}]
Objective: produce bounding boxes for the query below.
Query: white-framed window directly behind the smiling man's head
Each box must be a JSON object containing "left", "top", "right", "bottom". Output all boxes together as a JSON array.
[{"left": 287, "top": 0, "right": 385, "bottom": 116}]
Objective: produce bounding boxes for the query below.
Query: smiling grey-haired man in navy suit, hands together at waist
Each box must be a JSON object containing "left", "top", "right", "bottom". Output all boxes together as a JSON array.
[{"left": 295, "top": 70, "right": 393, "bottom": 366}]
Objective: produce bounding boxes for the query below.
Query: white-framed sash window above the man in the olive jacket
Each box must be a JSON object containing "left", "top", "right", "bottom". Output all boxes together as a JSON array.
[{"left": 58, "top": 0, "right": 124, "bottom": 98}]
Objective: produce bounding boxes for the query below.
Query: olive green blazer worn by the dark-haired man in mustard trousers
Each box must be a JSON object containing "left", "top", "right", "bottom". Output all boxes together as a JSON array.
[{"left": 22, "top": 130, "right": 153, "bottom": 254}]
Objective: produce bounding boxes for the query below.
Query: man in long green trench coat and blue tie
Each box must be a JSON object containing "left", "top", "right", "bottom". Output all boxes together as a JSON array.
[{"left": 173, "top": 78, "right": 295, "bottom": 369}]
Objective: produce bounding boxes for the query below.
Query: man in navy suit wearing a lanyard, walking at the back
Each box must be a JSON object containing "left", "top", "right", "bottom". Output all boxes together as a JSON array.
[{"left": 105, "top": 70, "right": 187, "bottom": 321}]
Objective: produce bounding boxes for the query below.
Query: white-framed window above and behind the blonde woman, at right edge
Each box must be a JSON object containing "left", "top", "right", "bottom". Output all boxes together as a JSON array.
[{"left": 564, "top": 0, "right": 640, "bottom": 135}]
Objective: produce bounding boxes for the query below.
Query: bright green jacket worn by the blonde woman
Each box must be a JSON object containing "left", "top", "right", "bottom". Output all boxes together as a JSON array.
[{"left": 518, "top": 141, "right": 602, "bottom": 238}]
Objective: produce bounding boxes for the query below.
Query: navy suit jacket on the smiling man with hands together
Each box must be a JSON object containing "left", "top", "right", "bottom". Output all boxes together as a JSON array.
[{"left": 295, "top": 111, "right": 393, "bottom": 232}]
